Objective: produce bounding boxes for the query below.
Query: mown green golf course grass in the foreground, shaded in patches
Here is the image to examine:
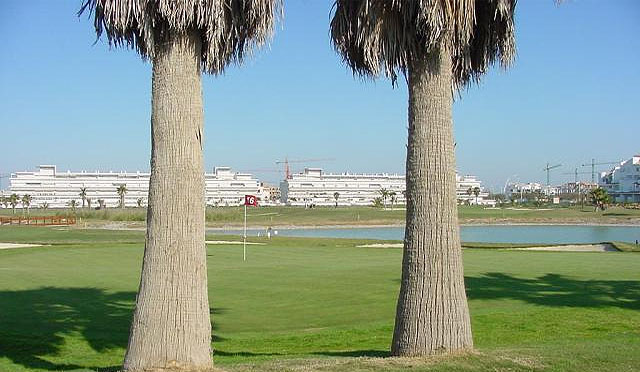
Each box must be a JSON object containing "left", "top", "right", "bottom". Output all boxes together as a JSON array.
[{"left": 0, "top": 227, "right": 640, "bottom": 372}]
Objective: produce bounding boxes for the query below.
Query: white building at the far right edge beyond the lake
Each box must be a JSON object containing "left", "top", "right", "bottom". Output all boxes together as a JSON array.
[{"left": 598, "top": 155, "right": 640, "bottom": 203}]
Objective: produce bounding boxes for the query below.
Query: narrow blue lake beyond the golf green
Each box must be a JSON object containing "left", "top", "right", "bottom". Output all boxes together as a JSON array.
[{"left": 214, "top": 225, "right": 640, "bottom": 244}]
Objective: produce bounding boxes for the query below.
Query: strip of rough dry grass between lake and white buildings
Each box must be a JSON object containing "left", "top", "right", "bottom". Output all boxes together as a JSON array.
[{"left": 0, "top": 206, "right": 640, "bottom": 227}]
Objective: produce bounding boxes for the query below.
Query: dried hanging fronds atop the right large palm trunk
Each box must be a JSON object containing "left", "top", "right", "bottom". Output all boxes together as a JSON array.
[{"left": 331, "top": 0, "right": 516, "bottom": 87}]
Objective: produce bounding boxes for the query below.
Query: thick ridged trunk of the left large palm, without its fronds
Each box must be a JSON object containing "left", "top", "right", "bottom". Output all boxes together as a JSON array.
[{"left": 124, "top": 32, "right": 212, "bottom": 371}]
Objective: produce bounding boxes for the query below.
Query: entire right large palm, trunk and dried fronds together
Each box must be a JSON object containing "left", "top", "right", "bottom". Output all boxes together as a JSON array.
[{"left": 331, "top": 0, "right": 515, "bottom": 355}]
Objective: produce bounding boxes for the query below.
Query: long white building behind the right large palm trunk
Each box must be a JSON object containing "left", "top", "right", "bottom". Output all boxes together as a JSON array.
[{"left": 280, "top": 168, "right": 495, "bottom": 206}]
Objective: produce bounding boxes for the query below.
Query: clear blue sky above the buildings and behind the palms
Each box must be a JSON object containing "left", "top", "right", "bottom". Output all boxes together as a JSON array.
[{"left": 0, "top": 0, "right": 640, "bottom": 190}]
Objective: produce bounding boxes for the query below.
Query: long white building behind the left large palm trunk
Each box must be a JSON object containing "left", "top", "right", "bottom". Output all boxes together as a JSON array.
[{"left": 9, "top": 165, "right": 265, "bottom": 208}]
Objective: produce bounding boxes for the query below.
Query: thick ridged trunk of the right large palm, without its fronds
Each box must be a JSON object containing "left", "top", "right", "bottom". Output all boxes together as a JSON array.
[{"left": 391, "top": 48, "right": 473, "bottom": 356}]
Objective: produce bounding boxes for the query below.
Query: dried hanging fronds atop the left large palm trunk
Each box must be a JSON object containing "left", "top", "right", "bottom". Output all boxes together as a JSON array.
[{"left": 78, "top": 0, "right": 282, "bottom": 74}]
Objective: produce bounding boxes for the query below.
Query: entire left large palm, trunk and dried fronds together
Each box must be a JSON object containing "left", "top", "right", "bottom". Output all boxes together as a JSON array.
[{"left": 80, "top": 0, "right": 282, "bottom": 371}]
